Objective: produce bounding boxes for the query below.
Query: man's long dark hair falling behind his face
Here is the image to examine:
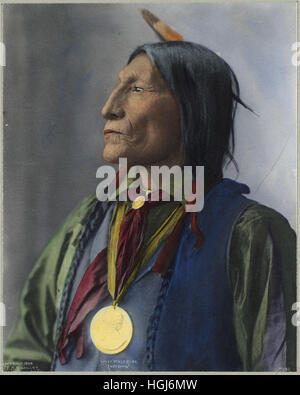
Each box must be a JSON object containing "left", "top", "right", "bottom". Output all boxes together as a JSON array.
[{"left": 128, "top": 41, "right": 252, "bottom": 189}]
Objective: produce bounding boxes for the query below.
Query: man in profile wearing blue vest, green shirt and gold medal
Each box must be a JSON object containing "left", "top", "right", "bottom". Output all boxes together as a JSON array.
[{"left": 5, "top": 42, "right": 296, "bottom": 371}]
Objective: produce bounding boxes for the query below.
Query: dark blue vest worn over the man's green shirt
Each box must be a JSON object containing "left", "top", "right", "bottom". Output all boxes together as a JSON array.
[{"left": 53, "top": 179, "right": 255, "bottom": 371}]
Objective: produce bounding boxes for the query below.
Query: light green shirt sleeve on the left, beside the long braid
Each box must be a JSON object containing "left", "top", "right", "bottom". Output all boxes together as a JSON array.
[{"left": 3, "top": 197, "right": 95, "bottom": 371}]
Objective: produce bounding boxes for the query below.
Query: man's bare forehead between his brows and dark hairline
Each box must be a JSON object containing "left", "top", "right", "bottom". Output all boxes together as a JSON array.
[{"left": 119, "top": 54, "right": 164, "bottom": 84}]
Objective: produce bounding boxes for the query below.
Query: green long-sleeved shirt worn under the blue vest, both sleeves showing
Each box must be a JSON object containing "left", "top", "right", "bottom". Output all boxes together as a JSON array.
[{"left": 4, "top": 196, "right": 296, "bottom": 371}]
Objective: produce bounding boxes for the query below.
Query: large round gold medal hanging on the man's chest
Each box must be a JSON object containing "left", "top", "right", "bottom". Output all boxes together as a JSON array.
[{"left": 90, "top": 306, "right": 133, "bottom": 354}]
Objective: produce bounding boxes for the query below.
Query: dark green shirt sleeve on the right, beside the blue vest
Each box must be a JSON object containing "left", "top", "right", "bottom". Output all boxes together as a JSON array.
[{"left": 229, "top": 204, "right": 296, "bottom": 371}]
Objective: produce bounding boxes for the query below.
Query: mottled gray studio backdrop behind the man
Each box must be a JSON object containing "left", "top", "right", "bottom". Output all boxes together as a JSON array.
[{"left": 3, "top": 3, "right": 296, "bottom": 344}]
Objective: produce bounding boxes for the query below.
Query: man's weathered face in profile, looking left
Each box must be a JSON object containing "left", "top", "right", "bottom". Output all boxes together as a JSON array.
[{"left": 101, "top": 54, "right": 183, "bottom": 166}]
